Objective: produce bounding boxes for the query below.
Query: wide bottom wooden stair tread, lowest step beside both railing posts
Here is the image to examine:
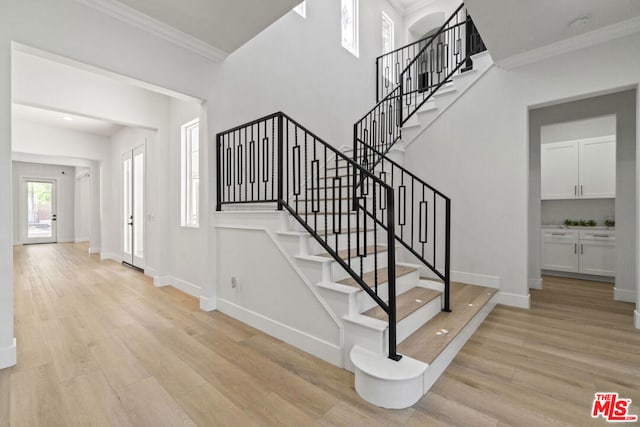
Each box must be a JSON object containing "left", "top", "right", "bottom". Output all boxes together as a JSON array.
[{"left": 398, "top": 282, "right": 497, "bottom": 364}]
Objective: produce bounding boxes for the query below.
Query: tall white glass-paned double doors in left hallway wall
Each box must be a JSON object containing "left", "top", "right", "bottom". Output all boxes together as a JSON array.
[{"left": 122, "top": 145, "right": 144, "bottom": 269}]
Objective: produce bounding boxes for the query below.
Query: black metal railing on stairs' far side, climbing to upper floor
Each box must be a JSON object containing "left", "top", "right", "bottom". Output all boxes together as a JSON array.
[{"left": 353, "top": 4, "right": 486, "bottom": 311}]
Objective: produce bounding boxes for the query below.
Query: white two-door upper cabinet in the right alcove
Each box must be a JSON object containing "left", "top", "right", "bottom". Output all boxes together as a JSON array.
[{"left": 540, "top": 136, "right": 616, "bottom": 200}]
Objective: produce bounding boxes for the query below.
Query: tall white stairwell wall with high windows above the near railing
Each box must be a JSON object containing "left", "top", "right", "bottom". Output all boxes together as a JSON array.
[{"left": 209, "top": 0, "right": 402, "bottom": 146}]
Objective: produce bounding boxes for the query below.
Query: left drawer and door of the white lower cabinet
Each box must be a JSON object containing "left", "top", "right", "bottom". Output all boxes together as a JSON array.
[{"left": 542, "top": 229, "right": 580, "bottom": 273}]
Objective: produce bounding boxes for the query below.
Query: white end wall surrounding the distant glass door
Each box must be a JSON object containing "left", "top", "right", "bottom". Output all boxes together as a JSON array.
[{"left": 12, "top": 162, "right": 75, "bottom": 245}]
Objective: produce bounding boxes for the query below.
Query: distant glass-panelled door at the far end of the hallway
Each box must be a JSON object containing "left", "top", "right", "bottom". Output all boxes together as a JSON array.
[{"left": 24, "top": 179, "right": 58, "bottom": 244}]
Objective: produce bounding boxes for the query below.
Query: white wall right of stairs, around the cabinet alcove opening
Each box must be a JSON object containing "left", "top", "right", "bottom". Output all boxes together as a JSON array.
[{"left": 405, "top": 31, "right": 640, "bottom": 305}]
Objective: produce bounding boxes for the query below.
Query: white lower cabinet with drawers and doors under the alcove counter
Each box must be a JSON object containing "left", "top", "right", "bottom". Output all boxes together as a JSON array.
[{"left": 542, "top": 229, "right": 616, "bottom": 276}]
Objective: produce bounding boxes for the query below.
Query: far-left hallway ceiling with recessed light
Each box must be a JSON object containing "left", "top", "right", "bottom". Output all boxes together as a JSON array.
[{"left": 11, "top": 104, "right": 123, "bottom": 137}]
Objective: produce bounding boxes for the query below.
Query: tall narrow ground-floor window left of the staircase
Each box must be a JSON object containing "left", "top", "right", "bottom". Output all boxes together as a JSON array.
[{"left": 180, "top": 119, "right": 200, "bottom": 227}]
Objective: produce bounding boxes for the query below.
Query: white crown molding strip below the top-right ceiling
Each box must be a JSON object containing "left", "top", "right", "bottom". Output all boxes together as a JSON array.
[{"left": 496, "top": 16, "right": 640, "bottom": 70}]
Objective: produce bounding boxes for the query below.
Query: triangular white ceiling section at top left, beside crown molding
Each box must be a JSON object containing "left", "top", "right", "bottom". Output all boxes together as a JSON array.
[{"left": 113, "top": 0, "right": 301, "bottom": 53}]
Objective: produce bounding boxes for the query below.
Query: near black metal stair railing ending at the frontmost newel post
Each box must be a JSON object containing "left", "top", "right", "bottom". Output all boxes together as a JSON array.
[{"left": 216, "top": 113, "right": 402, "bottom": 360}]
